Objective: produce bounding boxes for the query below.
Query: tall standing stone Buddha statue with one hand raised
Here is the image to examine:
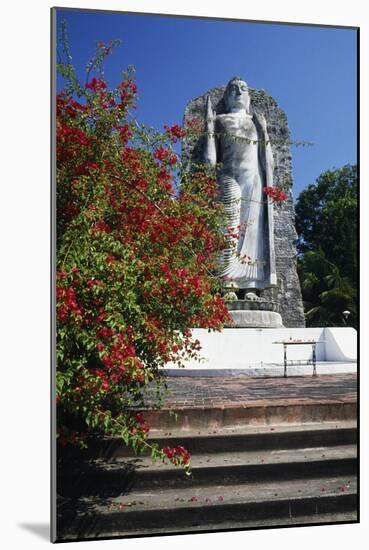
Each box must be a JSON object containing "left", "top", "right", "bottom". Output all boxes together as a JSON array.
[{"left": 203, "top": 77, "right": 277, "bottom": 290}]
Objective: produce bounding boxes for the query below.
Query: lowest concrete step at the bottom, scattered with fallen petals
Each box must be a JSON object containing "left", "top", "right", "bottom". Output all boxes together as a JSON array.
[{"left": 58, "top": 475, "right": 357, "bottom": 541}]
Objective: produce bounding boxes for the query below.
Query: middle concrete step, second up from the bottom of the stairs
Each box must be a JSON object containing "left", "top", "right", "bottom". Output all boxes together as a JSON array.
[{"left": 58, "top": 445, "right": 357, "bottom": 496}]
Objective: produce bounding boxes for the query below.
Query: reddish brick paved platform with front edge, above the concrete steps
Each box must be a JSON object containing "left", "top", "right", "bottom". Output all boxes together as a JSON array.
[{"left": 145, "top": 374, "right": 357, "bottom": 430}]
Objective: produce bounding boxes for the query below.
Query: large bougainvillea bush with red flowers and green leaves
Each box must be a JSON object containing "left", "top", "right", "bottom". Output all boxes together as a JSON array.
[{"left": 56, "top": 35, "right": 229, "bottom": 470}]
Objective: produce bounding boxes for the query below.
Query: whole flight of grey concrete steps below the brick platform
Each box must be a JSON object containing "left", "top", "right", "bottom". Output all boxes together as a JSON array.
[{"left": 57, "top": 422, "right": 357, "bottom": 541}]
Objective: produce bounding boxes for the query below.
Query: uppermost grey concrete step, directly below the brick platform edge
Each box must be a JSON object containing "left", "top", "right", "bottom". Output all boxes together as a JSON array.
[{"left": 62, "top": 420, "right": 357, "bottom": 462}]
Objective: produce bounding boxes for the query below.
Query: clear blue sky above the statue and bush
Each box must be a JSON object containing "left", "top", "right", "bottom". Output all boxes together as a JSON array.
[{"left": 57, "top": 9, "right": 357, "bottom": 198}]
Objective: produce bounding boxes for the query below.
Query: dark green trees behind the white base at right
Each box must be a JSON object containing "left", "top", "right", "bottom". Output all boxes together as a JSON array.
[{"left": 296, "top": 165, "right": 357, "bottom": 327}]
